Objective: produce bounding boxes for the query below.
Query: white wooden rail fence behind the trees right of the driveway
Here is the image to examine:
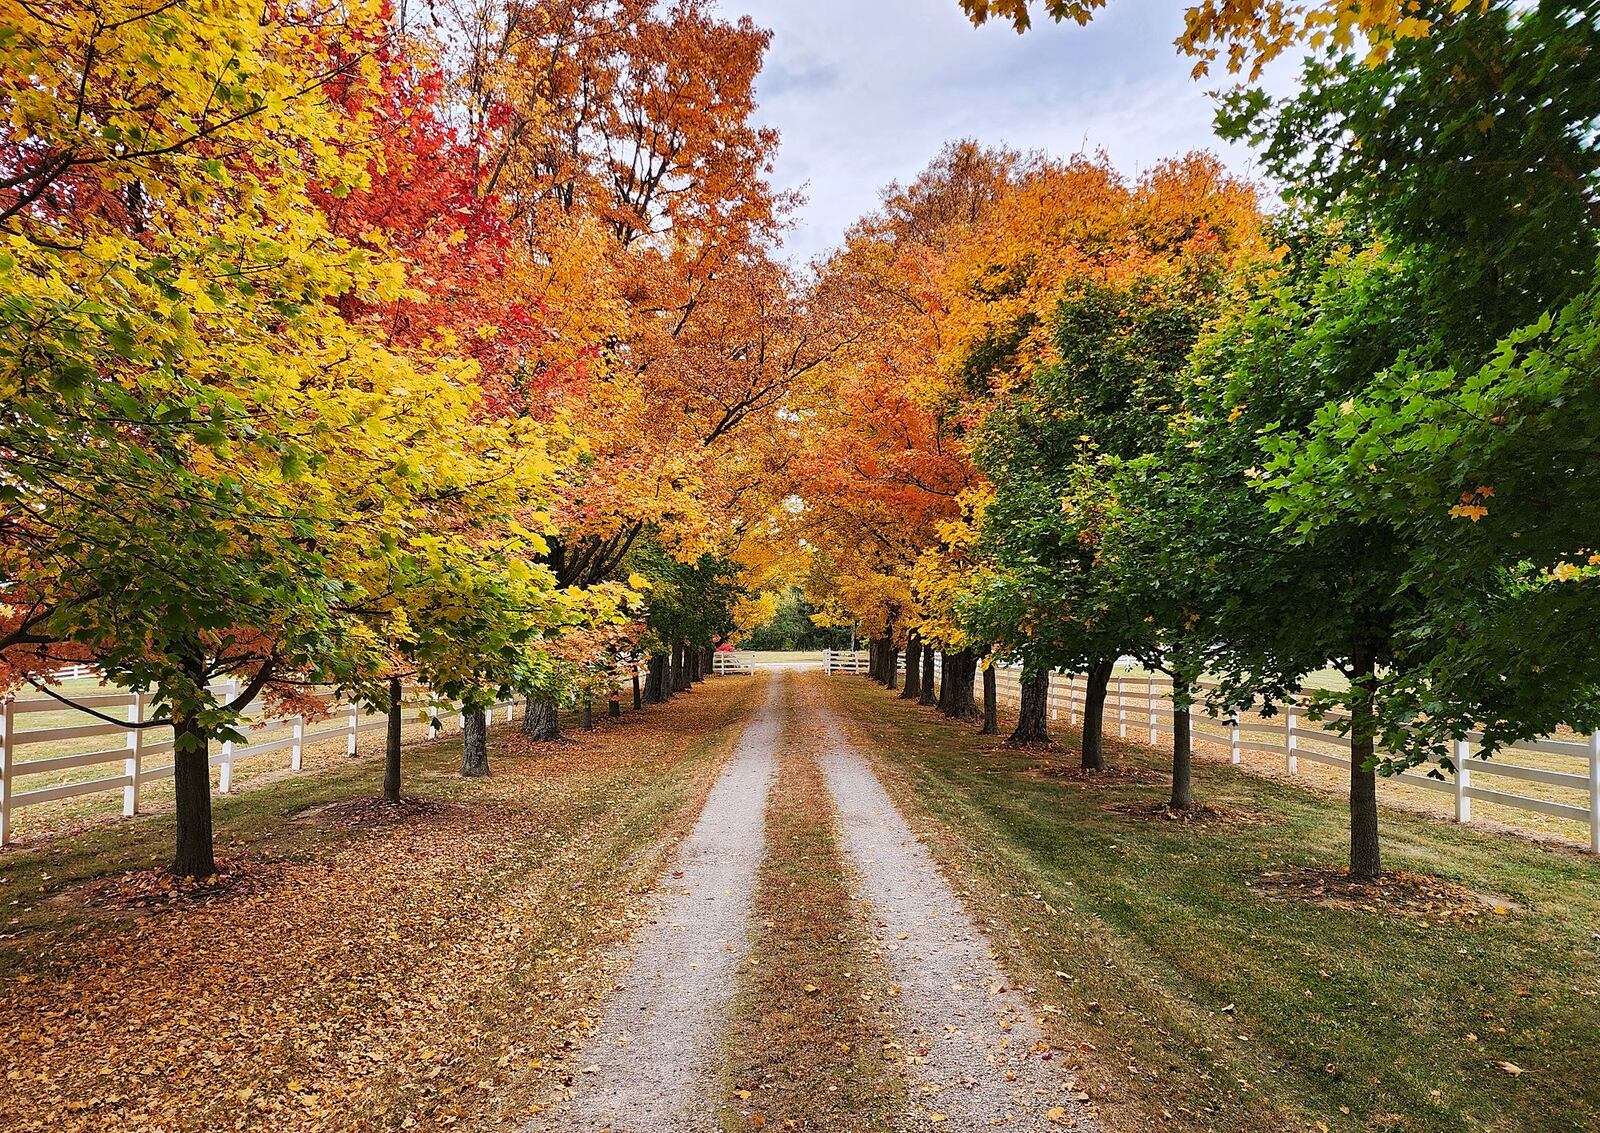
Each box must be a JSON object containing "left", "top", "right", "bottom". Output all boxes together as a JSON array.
[{"left": 829, "top": 655, "right": 1600, "bottom": 853}]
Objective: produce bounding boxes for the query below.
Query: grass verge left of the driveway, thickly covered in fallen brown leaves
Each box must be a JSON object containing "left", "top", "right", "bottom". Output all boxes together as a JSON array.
[{"left": 0, "top": 677, "right": 755, "bottom": 1133}]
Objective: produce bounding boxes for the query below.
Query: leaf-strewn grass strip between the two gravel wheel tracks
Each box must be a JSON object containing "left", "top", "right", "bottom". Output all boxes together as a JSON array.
[{"left": 720, "top": 682, "right": 906, "bottom": 1133}]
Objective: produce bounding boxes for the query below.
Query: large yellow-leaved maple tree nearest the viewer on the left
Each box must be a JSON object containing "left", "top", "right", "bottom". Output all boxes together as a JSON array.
[{"left": 0, "top": 5, "right": 592, "bottom": 875}]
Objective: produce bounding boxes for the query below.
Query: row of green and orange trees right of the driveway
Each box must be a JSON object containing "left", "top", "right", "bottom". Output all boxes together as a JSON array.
[{"left": 800, "top": 0, "right": 1600, "bottom": 877}]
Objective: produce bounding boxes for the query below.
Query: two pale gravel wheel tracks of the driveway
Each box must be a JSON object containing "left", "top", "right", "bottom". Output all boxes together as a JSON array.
[{"left": 526, "top": 672, "right": 1094, "bottom": 1133}]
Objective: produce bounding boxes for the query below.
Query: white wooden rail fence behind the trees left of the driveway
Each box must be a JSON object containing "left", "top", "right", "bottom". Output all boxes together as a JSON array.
[{"left": 0, "top": 681, "right": 515, "bottom": 845}]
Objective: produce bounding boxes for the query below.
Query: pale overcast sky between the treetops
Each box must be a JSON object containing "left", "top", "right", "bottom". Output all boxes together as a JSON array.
[{"left": 732, "top": 0, "right": 1292, "bottom": 261}]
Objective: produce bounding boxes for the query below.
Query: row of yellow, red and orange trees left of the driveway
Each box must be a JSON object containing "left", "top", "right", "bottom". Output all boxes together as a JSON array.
[{"left": 0, "top": 0, "right": 825, "bottom": 875}]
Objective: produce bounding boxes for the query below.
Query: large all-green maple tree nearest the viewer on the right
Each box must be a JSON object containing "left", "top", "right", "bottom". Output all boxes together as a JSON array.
[{"left": 1203, "top": 3, "right": 1600, "bottom": 872}]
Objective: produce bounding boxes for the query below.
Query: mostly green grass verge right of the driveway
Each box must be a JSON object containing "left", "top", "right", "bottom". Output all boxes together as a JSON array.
[{"left": 830, "top": 679, "right": 1600, "bottom": 1133}]
